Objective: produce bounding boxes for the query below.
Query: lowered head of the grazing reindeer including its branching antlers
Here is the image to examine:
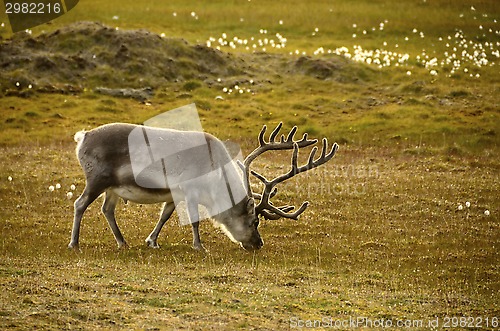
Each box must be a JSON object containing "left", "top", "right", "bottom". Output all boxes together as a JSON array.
[{"left": 233, "top": 123, "right": 338, "bottom": 250}]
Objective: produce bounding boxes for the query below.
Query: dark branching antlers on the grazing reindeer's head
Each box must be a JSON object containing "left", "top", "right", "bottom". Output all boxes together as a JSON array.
[{"left": 242, "top": 122, "right": 339, "bottom": 220}]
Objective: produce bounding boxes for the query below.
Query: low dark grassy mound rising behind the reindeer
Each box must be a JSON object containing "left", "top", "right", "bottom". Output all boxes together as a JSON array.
[{"left": 0, "top": 22, "right": 357, "bottom": 95}]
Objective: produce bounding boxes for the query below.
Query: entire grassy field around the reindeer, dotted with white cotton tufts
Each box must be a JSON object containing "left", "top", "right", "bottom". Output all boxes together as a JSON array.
[{"left": 0, "top": 0, "right": 500, "bottom": 330}]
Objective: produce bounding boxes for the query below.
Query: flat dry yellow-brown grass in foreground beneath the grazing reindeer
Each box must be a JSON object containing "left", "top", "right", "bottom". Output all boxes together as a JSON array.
[{"left": 0, "top": 145, "right": 499, "bottom": 330}]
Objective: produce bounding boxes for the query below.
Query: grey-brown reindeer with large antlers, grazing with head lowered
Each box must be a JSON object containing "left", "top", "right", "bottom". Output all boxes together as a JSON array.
[{"left": 68, "top": 123, "right": 338, "bottom": 251}]
